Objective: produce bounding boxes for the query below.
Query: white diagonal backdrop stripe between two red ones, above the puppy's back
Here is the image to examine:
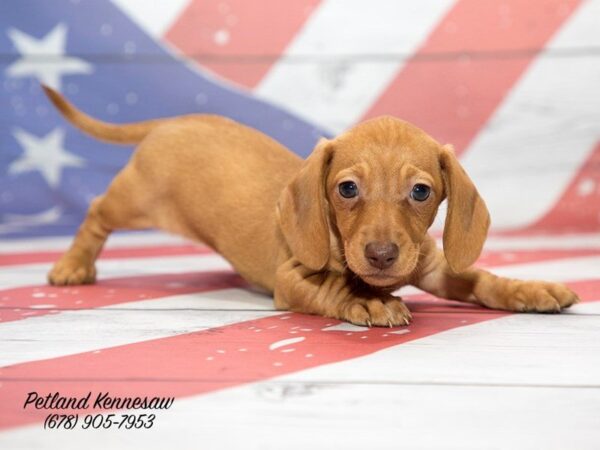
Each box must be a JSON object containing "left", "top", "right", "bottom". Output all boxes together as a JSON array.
[{"left": 255, "top": 0, "right": 454, "bottom": 133}]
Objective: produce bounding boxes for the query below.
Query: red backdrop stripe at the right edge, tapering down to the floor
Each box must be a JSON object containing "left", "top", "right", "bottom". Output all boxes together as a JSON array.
[{"left": 507, "top": 144, "right": 600, "bottom": 234}]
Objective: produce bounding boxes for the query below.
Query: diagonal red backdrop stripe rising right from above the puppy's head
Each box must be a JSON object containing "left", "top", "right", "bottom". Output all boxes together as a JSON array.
[{"left": 365, "top": 0, "right": 581, "bottom": 153}]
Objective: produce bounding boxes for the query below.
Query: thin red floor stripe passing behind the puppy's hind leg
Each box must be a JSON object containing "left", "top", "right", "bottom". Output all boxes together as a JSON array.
[{"left": 0, "top": 244, "right": 214, "bottom": 266}]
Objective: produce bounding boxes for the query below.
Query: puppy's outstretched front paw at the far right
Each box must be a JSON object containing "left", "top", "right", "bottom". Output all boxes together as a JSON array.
[{"left": 506, "top": 281, "right": 579, "bottom": 312}]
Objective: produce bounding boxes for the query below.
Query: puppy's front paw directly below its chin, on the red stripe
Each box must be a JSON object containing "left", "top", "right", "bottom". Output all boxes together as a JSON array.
[{"left": 340, "top": 295, "right": 412, "bottom": 327}]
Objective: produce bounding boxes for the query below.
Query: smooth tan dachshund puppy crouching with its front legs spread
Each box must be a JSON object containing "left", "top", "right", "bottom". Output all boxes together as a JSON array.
[{"left": 45, "top": 88, "right": 578, "bottom": 326}]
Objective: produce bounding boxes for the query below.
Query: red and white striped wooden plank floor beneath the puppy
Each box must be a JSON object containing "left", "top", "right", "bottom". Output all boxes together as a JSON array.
[{"left": 0, "top": 237, "right": 600, "bottom": 449}]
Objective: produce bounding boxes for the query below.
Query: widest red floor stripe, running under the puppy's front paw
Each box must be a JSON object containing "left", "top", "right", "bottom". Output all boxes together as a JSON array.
[{"left": 0, "top": 280, "right": 600, "bottom": 428}]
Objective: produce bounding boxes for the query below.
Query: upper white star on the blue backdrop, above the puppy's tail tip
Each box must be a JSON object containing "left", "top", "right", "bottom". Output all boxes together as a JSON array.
[{"left": 6, "top": 23, "right": 93, "bottom": 89}]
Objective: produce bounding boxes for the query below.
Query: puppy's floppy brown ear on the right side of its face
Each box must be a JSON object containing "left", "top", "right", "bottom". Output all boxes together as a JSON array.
[{"left": 440, "top": 145, "right": 490, "bottom": 273}]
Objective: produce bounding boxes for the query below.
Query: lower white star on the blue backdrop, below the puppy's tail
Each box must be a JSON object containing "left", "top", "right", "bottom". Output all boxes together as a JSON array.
[{"left": 8, "top": 128, "right": 85, "bottom": 188}]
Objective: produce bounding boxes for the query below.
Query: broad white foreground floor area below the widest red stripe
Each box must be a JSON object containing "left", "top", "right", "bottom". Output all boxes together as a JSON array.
[{"left": 0, "top": 316, "right": 600, "bottom": 450}]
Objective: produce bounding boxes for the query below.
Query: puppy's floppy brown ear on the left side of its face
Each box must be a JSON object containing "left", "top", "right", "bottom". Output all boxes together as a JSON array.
[{"left": 278, "top": 139, "right": 332, "bottom": 270}]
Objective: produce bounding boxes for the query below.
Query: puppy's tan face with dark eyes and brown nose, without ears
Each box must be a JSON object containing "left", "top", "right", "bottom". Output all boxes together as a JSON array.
[{"left": 326, "top": 118, "right": 445, "bottom": 287}]
